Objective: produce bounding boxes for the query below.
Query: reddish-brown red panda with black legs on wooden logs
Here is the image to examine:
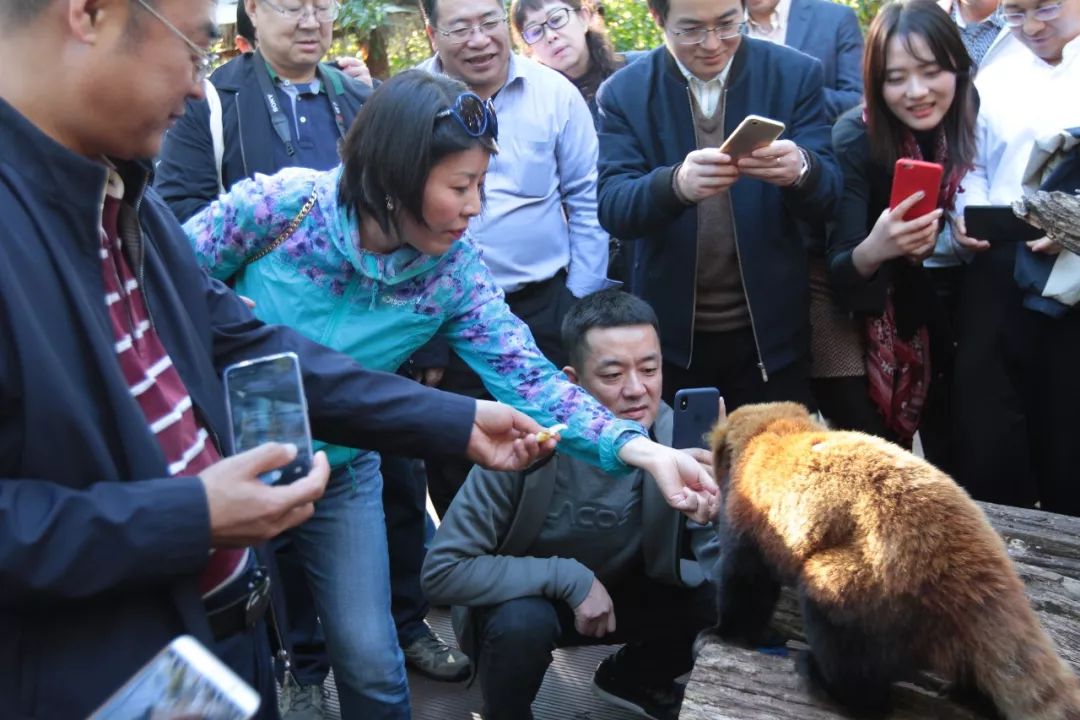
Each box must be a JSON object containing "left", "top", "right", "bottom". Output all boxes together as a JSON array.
[{"left": 712, "top": 403, "right": 1080, "bottom": 720}]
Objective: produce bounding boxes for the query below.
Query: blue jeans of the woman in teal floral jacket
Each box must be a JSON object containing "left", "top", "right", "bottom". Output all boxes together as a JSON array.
[{"left": 289, "top": 452, "right": 411, "bottom": 720}]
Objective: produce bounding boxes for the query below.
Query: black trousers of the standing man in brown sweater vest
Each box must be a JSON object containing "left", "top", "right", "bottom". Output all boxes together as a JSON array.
[{"left": 663, "top": 327, "right": 818, "bottom": 412}]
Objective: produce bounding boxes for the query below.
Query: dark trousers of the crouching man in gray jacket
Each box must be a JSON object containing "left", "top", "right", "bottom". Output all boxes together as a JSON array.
[{"left": 473, "top": 573, "right": 715, "bottom": 720}]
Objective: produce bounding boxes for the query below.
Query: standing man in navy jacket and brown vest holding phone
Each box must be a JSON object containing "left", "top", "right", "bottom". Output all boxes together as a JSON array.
[{"left": 598, "top": 0, "right": 841, "bottom": 416}]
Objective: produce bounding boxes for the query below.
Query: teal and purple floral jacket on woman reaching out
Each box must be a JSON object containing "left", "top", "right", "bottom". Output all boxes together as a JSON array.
[{"left": 184, "top": 167, "right": 647, "bottom": 473}]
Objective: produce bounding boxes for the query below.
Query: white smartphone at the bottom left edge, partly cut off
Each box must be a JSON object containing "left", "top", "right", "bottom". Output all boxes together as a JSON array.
[{"left": 90, "top": 635, "right": 259, "bottom": 720}]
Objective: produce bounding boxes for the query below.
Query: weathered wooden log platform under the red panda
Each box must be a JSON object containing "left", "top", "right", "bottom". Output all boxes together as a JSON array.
[{"left": 679, "top": 503, "right": 1080, "bottom": 720}]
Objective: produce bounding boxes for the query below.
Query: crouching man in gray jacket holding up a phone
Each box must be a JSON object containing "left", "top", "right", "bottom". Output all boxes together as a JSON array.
[{"left": 423, "top": 290, "right": 715, "bottom": 720}]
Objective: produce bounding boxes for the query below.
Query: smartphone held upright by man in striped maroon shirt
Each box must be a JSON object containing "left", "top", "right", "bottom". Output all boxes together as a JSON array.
[{"left": 225, "top": 353, "right": 312, "bottom": 485}]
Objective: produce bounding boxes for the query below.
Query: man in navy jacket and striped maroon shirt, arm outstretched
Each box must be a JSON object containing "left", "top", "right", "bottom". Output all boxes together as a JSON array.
[{"left": 0, "top": 0, "right": 552, "bottom": 719}]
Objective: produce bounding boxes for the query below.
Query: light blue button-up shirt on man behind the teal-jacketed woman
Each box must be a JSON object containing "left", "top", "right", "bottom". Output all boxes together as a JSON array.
[{"left": 419, "top": 54, "right": 609, "bottom": 297}]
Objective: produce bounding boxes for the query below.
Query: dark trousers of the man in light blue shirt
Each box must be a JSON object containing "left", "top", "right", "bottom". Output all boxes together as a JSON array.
[{"left": 426, "top": 271, "right": 575, "bottom": 517}]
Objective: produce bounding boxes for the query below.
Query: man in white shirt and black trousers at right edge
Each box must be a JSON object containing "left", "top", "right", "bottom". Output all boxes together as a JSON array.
[{"left": 954, "top": 0, "right": 1080, "bottom": 515}]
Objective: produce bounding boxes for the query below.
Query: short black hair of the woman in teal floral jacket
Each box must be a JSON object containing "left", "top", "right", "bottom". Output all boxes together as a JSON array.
[{"left": 338, "top": 70, "right": 498, "bottom": 239}]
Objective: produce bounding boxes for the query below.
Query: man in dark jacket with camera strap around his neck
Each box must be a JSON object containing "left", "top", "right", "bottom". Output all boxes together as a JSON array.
[{"left": 154, "top": 0, "right": 370, "bottom": 221}]
